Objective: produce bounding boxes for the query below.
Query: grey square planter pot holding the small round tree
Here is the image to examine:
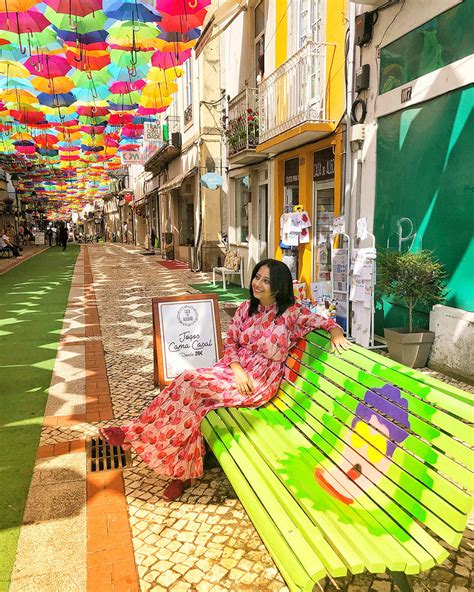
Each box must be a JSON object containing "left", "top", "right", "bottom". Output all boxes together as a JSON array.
[{"left": 385, "top": 328, "right": 435, "bottom": 368}]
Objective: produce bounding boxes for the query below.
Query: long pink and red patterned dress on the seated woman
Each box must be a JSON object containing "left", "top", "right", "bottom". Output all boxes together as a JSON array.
[{"left": 103, "top": 301, "right": 336, "bottom": 480}]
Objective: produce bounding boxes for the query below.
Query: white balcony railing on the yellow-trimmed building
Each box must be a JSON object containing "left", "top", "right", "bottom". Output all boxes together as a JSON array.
[{"left": 258, "top": 41, "right": 328, "bottom": 144}]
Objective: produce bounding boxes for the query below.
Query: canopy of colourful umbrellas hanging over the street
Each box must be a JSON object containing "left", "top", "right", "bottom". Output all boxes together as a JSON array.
[{"left": 0, "top": 0, "right": 211, "bottom": 218}]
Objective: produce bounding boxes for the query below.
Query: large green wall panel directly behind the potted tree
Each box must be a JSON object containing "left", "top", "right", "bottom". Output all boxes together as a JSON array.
[{"left": 374, "top": 86, "right": 474, "bottom": 334}]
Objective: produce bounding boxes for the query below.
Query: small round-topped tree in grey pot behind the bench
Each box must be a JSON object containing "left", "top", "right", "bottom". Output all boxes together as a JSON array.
[{"left": 377, "top": 250, "right": 446, "bottom": 368}]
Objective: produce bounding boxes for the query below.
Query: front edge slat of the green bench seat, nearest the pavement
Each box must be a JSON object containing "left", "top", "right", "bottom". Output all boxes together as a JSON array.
[{"left": 201, "top": 418, "right": 313, "bottom": 592}]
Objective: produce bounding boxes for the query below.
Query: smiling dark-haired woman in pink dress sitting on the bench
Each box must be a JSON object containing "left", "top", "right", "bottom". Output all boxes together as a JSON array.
[{"left": 100, "top": 259, "right": 349, "bottom": 500}]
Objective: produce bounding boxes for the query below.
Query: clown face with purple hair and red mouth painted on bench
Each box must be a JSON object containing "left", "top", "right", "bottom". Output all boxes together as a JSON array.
[{"left": 314, "top": 384, "right": 410, "bottom": 504}]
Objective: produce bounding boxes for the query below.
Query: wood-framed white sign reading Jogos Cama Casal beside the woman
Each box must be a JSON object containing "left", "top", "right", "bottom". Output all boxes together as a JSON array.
[{"left": 152, "top": 294, "right": 221, "bottom": 388}]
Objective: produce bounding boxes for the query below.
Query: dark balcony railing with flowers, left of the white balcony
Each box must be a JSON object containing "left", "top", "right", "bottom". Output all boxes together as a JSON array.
[{"left": 225, "top": 88, "right": 259, "bottom": 157}]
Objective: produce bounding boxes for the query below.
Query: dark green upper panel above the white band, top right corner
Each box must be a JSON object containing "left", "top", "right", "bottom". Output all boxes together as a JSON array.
[{"left": 379, "top": 0, "right": 474, "bottom": 94}]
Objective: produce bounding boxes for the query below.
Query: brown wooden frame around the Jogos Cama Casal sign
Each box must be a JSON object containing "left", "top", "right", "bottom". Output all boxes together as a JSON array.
[{"left": 151, "top": 294, "right": 222, "bottom": 389}]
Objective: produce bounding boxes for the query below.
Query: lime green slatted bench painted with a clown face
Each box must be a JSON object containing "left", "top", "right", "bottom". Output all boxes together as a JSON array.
[{"left": 202, "top": 332, "right": 474, "bottom": 590}]
